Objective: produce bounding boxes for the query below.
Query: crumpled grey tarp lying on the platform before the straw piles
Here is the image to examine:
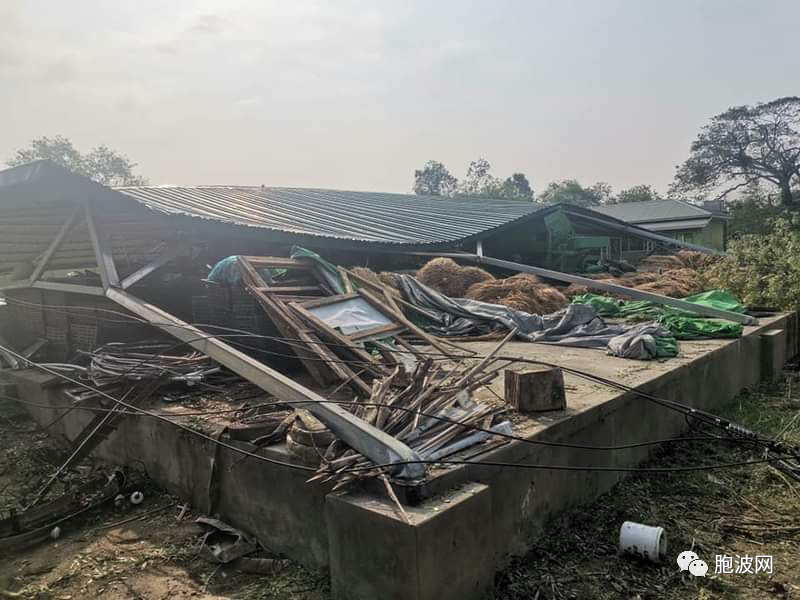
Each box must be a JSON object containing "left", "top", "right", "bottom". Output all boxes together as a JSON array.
[{"left": 398, "top": 275, "right": 671, "bottom": 359}]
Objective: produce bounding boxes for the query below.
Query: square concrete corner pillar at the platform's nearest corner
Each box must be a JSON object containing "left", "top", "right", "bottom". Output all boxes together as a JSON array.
[{"left": 326, "top": 483, "right": 494, "bottom": 600}]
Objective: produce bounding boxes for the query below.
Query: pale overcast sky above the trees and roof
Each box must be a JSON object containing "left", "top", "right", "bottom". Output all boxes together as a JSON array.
[{"left": 0, "top": 0, "right": 800, "bottom": 192}]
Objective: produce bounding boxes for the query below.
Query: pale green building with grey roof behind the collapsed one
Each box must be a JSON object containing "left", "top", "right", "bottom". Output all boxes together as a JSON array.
[{"left": 592, "top": 200, "right": 730, "bottom": 251}]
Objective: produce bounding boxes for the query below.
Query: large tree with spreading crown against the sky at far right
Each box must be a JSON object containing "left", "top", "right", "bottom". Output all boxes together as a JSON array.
[{"left": 673, "top": 96, "right": 800, "bottom": 206}]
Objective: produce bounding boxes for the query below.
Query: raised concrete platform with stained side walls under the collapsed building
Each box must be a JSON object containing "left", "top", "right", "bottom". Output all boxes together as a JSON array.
[{"left": 9, "top": 313, "right": 798, "bottom": 600}]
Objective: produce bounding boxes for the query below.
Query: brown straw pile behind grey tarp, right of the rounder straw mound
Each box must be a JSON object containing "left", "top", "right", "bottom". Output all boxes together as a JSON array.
[{"left": 467, "top": 273, "right": 569, "bottom": 315}]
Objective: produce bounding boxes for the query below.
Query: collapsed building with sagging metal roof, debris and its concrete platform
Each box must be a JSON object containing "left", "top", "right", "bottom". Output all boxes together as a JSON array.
[{"left": 0, "top": 161, "right": 797, "bottom": 599}]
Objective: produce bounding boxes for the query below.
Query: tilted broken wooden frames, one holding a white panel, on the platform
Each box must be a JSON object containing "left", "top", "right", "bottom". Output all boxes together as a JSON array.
[{"left": 231, "top": 256, "right": 464, "bottom": 397}]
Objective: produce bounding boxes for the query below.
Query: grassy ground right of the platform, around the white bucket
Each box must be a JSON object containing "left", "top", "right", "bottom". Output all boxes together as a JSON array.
[{"left": 495, "top": 381, "right": 800, "bottom": 600}]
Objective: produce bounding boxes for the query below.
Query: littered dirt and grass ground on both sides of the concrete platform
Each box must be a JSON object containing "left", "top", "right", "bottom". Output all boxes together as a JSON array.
[{"left": 0, "top": 375, "right": 800, "bottom": 600}]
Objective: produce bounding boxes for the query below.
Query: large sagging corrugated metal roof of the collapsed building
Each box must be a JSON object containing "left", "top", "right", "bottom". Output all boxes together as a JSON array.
[{"left": 115, "top": 186, "right": 548, "bottom": 245}]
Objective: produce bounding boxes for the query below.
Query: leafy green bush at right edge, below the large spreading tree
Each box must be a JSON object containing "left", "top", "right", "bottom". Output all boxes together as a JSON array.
[{"left": 706, "top": 213, "right": 800, "bottom": 310}]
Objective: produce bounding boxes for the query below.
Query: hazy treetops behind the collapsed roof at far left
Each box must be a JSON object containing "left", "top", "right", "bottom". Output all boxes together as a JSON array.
[{"left": 6, "top": 135, "right": 147, "bottom": 186}]
